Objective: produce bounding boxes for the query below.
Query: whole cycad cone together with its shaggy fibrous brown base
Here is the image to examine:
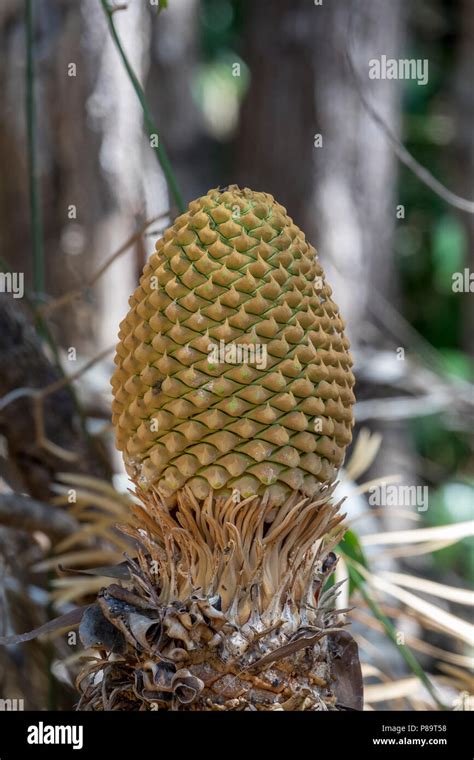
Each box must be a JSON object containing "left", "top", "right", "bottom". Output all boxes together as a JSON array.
[{"left": 81, "top": 186, "right": 355, "bottom": 710}]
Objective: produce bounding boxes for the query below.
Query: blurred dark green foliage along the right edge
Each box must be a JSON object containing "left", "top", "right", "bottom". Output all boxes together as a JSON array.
[{"left": 396, "top": 0, "right": 474, "bottom": 579}]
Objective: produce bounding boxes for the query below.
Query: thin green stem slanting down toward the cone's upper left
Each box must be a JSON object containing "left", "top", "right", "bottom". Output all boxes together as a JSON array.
[{"left": 100, "top": 0, "right": 185, "bottom": 213}]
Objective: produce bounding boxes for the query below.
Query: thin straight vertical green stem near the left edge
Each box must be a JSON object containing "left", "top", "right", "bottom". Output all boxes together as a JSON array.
[{"left": 25, "top": 0, "right": 45, "bottom": 299}]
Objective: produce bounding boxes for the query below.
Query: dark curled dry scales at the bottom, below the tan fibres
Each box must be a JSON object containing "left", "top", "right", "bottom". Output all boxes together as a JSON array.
[{"left": 78, "top": 586, "right": 361, "bottom": 711}]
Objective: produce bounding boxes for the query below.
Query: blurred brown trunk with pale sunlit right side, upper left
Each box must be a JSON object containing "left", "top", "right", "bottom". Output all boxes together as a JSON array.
[{"left": 0, "top": 0, "right": 168, "bottom": 355}]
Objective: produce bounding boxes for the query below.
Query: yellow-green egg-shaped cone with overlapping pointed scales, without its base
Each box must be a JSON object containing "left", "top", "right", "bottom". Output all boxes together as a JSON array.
[{"left": 112, "top": 185, "right": 354, "bottom": 505}]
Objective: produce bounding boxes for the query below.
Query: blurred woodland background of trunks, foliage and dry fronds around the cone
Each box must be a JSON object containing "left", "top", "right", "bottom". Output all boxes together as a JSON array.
[{"left": 0, "top": 0, "right": 474, "bottom": 709}]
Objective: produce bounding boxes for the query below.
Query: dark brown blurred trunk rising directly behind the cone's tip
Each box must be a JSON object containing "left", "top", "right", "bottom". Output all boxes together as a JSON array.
[{"left": 235, "top": 0, "right": 320, "bottom": 227}]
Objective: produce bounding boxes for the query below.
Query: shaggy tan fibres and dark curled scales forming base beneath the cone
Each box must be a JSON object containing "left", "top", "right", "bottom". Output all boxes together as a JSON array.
[{"left": 78, "top": 486, "right": 360, "bottom": 710}]
